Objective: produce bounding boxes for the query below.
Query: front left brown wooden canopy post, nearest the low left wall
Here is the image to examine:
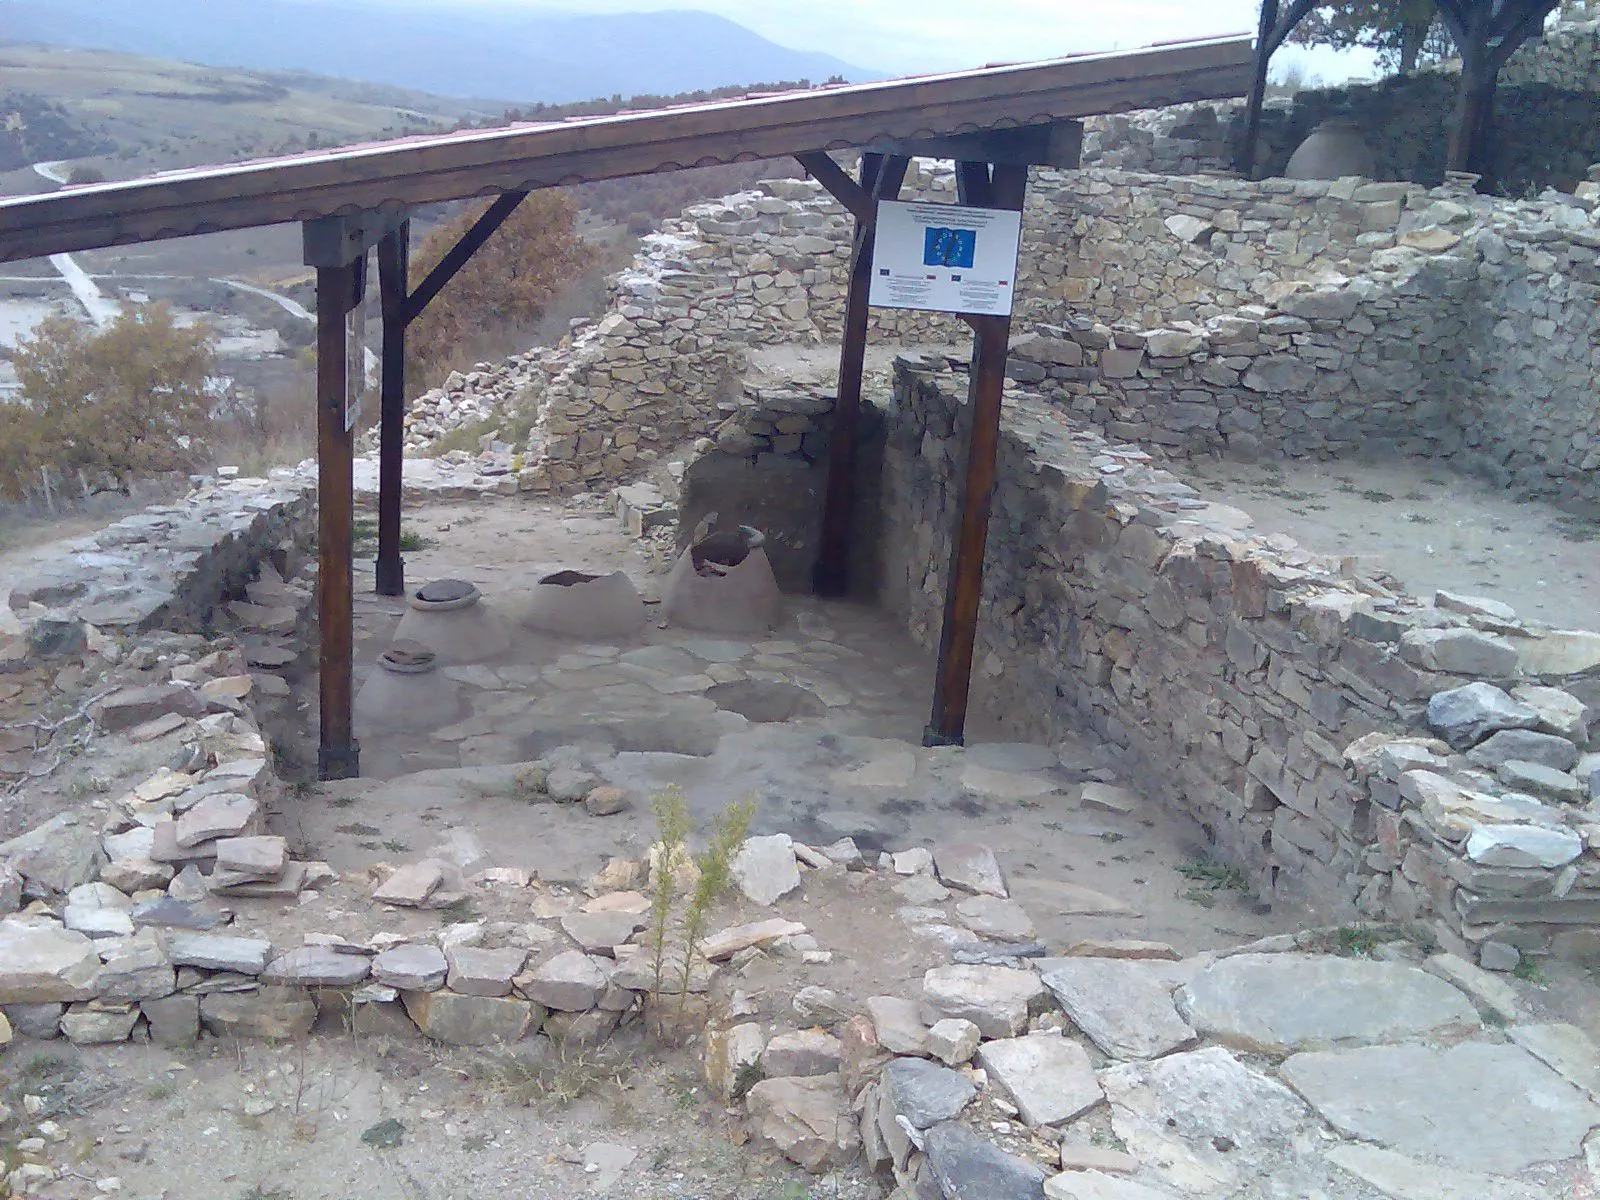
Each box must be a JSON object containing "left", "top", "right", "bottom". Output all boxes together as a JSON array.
[{"left": 317, "top": 262, "right": 362, "bottom": 779}]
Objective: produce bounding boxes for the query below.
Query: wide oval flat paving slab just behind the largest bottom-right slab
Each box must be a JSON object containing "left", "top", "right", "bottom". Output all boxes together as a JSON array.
[{"left": 1178, "top": 954, "right": 1480, "bottom": 1054}]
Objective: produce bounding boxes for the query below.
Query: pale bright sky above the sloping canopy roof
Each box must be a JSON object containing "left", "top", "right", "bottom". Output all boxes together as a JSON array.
[{"left": 460, "top": 0, "right": 1371, "bottom": 82}]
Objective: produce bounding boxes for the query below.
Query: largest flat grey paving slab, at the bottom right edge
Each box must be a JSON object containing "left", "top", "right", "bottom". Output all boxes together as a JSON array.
[{"left": 1280, "top": 1042, "right": 1600, "bottom": 1174}]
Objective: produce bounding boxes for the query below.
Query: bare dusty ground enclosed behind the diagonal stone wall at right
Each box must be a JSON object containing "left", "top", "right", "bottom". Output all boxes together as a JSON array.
[{"left": 1173, "top": 461, "right": 1600, "bottom": 629}]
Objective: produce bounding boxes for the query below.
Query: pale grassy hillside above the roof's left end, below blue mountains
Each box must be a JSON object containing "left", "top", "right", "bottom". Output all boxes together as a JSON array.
[{"left": 0, "top": 44, "right": 499, "bottom": 178}]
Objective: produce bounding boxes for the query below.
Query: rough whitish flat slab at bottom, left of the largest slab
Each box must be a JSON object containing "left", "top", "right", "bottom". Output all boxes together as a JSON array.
[{"left": 1101, "top": 1046, "right": 1312, "bottom": 1195}]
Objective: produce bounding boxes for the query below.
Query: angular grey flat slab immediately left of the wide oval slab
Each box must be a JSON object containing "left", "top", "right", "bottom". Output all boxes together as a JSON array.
[{"left": 1038, "top": 958, "right": 1195, "bottom": 1059}]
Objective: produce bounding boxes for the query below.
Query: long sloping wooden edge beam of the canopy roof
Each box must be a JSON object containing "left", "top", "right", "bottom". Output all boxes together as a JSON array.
[{"left": 0, "top": 38, "right": 1251, "bottom": 261}]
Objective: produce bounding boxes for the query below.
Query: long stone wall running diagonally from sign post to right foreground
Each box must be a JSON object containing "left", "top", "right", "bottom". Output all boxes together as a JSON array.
[{"left": 880, "top": 357, "right": 1600, "bottom": 965}]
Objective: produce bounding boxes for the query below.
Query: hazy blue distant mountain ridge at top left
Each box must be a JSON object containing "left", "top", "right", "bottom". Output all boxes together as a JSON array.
[{"left": 0, "top": 0, "right": 882, "bottom": 104}]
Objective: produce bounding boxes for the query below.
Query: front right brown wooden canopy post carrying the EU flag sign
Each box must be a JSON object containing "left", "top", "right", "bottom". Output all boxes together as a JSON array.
[{"left": 922, "top": 162, "right": 1027, "bottom": 746}]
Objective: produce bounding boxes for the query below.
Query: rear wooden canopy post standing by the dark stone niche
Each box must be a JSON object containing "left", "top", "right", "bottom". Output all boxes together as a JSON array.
[{"left": 811, "top": 152, "right": 910, "bottom": 597}]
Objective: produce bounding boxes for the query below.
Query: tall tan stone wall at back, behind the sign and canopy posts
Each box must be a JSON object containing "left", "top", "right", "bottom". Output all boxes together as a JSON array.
[{"left": 454, "top": 160, "right": 1600, "bottom": 501}]
